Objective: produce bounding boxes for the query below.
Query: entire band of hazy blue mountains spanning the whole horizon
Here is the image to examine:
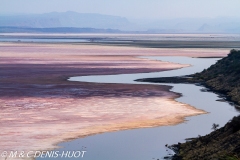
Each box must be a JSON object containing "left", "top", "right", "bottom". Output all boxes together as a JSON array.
[{"left": 0, "top": 11, "right": 240, "bottom": 33}]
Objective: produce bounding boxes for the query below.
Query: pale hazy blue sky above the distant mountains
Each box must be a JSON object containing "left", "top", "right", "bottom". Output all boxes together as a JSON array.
[{"left": 0, "top": 0, "right": 240, "bottom": 19}]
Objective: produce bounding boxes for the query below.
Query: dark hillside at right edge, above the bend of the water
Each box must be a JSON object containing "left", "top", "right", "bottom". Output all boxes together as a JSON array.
[{"left": 192, "top": 50, "right": 240, "bottom": 104}]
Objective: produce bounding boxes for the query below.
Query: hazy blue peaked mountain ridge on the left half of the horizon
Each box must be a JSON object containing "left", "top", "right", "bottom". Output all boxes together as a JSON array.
[{"left": 0, "top": 11, "right": 131, "bottom": 29}]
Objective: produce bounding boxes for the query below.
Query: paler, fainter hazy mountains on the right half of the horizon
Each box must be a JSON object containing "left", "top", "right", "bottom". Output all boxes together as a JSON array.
[{"left": 134, "top": 17, "right": 240, "bottom": 33}]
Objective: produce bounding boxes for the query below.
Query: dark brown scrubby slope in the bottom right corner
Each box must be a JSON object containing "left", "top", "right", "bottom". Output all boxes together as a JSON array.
[{"left": 170, "top": 116, "right": 240, "bottom": 160}]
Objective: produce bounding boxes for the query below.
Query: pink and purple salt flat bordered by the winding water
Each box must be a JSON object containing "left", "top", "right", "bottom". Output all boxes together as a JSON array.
[{"left": 0, "top": 42, "right": 228, "bottom": 159}]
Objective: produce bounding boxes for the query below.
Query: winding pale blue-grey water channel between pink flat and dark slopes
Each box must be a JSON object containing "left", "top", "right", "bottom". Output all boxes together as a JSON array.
[{"left": 39, "top": 57, "right": 239, "bottom": 160}]
